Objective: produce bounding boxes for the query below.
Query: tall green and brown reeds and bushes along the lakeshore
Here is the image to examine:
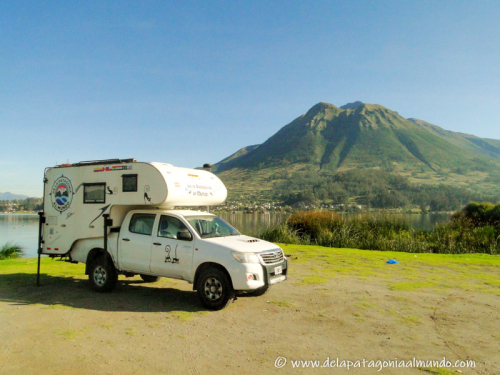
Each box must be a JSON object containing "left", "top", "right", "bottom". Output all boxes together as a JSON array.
[{"left": 260, "top": 209, "right": 500, "bottom": 254}]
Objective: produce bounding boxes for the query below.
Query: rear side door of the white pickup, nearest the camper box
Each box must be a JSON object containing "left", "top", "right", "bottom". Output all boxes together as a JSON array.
[{"left": 118, "top": 213, "right": 157, "bottom": 273}]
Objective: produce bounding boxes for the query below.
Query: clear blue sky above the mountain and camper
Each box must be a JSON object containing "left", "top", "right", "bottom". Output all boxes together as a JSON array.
[{"left": 0, "top": 0, "right": 500, "bottom": 196}]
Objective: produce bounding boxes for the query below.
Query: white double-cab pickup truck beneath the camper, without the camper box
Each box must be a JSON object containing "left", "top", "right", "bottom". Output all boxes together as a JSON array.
[{"left": 76, "top": 210, "right": 287, "bottom": 310}]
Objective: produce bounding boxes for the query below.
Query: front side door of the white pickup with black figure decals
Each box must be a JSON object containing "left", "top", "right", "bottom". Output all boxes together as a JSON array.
[{"left": 151, "top": 215, "right": 194, "bottom": 280}]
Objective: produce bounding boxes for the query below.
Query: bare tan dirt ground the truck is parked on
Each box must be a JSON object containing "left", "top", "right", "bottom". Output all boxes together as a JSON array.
[{"left": 0, "top": 247, "right": 500, "bottom": 375}]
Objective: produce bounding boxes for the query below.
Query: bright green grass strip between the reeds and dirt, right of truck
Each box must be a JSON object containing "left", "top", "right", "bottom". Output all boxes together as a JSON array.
[{"left": 280, "top": 244, "right": 500, "bottom": 295}]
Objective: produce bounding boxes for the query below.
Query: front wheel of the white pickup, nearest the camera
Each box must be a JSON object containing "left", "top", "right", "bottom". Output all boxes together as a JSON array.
[{"left": 196, "top": 267, "right": 236, "bottom": 310}]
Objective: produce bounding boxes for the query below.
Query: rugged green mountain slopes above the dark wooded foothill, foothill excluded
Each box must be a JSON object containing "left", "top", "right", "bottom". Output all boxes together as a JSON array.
[{"left": 212, "top": 101, "right": 500, "bottom": 203}]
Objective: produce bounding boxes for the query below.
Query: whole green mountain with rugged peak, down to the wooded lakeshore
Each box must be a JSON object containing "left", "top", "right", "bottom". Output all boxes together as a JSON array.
[{"left": 212, "top": 102, "right": 500, "bottom": 209}]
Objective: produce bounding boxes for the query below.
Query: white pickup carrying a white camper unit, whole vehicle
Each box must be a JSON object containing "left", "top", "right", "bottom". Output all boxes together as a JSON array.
[{"left": 37, "top": 159, "right": 288, "bottom": 310}]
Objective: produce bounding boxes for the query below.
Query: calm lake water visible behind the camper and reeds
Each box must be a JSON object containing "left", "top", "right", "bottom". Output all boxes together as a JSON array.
[{"left": 0, "top": 212, "right": 451, "bottom": 257}]
